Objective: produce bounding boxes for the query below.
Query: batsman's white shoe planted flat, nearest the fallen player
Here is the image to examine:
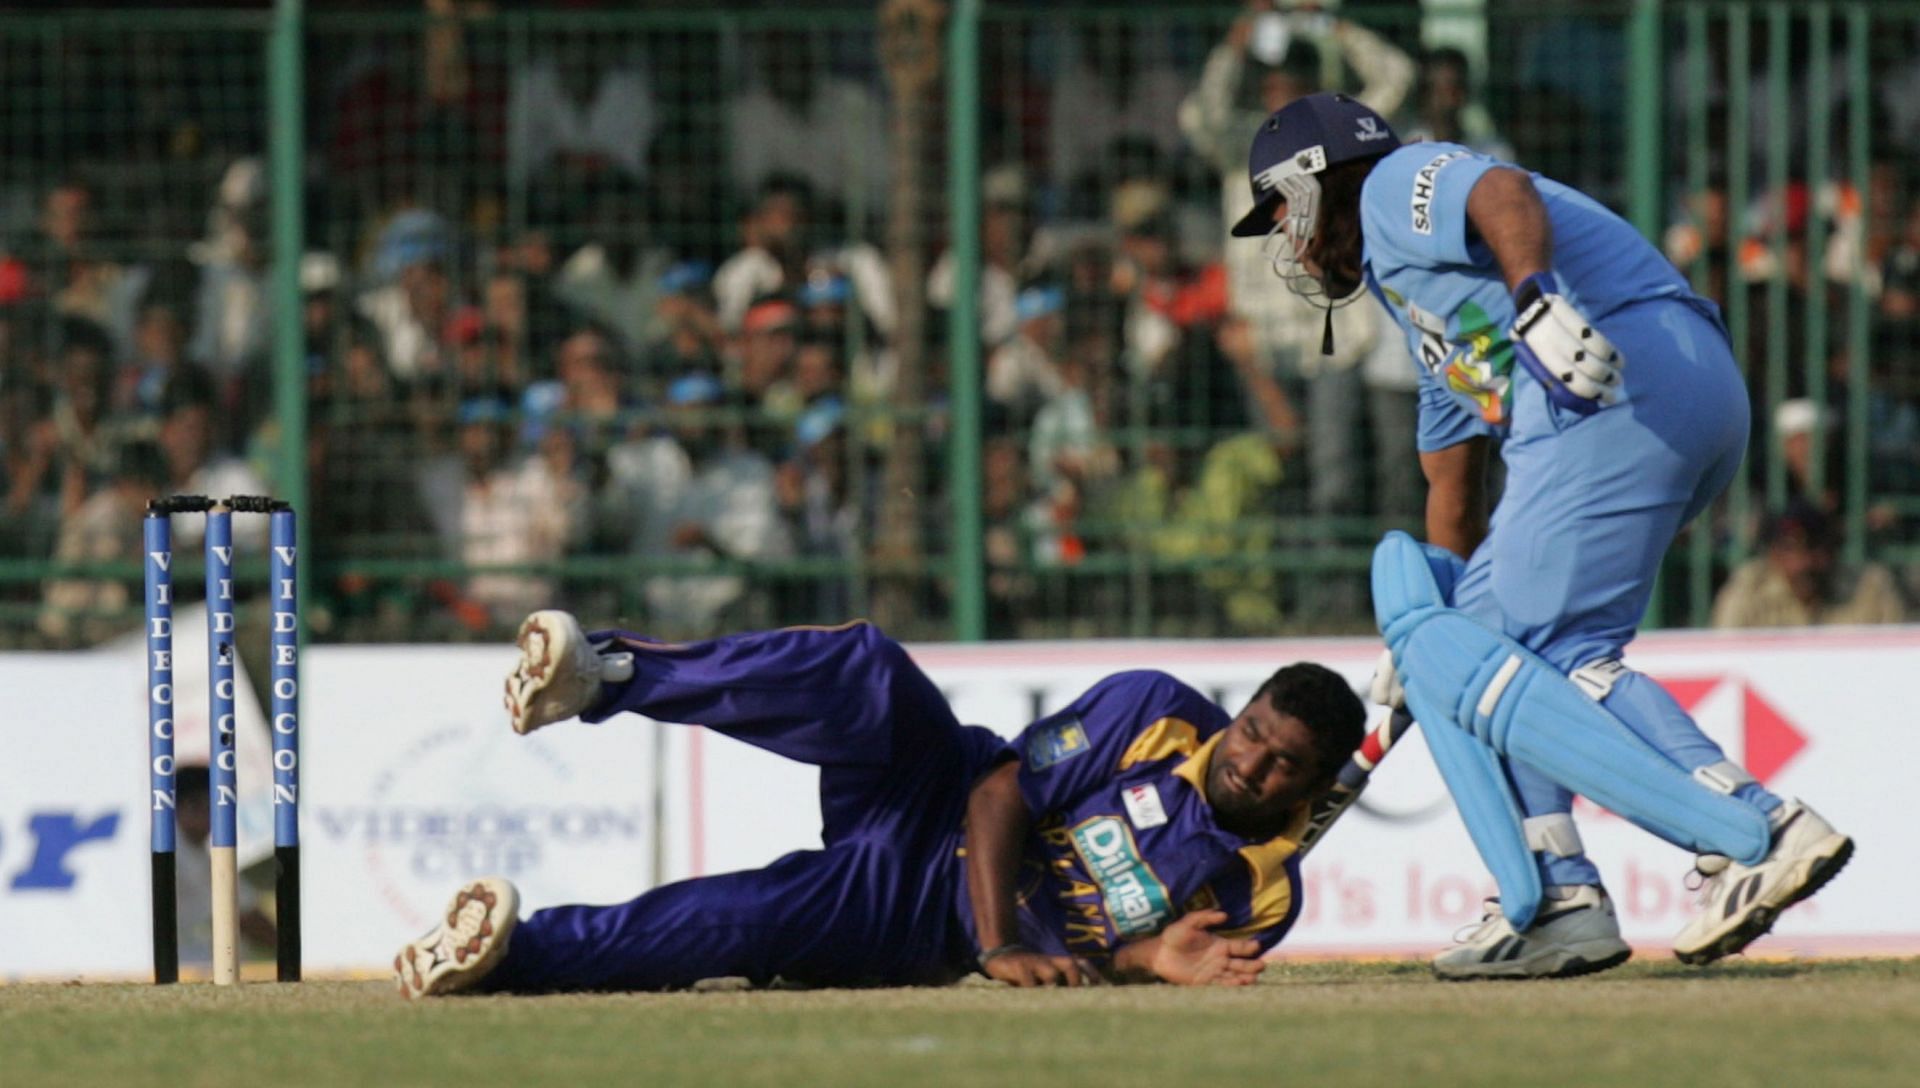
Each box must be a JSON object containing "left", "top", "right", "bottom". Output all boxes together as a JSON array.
[{"left": 1432, "top": 885, "right": 1634, "bottom": 982}]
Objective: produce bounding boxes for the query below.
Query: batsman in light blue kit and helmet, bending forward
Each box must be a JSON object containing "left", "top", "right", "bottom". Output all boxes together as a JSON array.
[{"left": 1233, "top": 94, "right": 1853, "bottom": 979}]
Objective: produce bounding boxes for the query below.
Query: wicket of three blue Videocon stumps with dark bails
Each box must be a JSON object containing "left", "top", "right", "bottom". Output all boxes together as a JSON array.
[{"left": 142, "top": 495, "right": 300, "bottom": 986}]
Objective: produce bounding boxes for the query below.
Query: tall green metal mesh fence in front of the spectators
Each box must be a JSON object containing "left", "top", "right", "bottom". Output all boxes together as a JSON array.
[{"left": 0, "top": 0, "right": 1920, "bottom": 645}]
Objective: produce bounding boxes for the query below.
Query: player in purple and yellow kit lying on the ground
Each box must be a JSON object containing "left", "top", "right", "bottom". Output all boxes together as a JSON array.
[{"left": 394, "top": 612, "right": 1365, "bottom": 998}]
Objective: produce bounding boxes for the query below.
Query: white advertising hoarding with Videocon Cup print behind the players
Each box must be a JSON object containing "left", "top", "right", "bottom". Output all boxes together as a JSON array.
[{"left": 0, "top": 627, "right": 1920, "bottom": 979}]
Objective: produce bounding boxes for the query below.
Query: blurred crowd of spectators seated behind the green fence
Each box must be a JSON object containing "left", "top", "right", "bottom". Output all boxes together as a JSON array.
[{"left": 0, "top": 0, "right": 1920, "bottom": 645}]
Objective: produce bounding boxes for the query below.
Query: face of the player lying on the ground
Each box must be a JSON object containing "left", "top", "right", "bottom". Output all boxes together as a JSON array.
[{"left": 1206, "top": 698, "right": 1325, "bottom": 833}]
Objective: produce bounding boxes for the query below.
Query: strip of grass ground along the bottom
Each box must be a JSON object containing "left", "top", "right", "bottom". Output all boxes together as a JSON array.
[{"left": 0, "top": 959, "right": 1920, "bottom": 1088}]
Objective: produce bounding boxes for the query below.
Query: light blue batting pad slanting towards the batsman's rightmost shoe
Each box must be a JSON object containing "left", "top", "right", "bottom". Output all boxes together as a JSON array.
[{"left": 1373, "top": 532, "right": 1770, "bottom": 863}]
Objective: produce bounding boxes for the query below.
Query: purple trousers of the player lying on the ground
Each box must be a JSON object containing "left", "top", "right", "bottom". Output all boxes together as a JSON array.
[{"left": 482, "top": 624, "right": 1012, "bottom": 992}]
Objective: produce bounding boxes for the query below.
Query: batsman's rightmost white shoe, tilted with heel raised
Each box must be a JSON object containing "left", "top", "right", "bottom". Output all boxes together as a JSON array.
[{"left": 1674, "top": 800, "right": 1853, "bottom": 963}]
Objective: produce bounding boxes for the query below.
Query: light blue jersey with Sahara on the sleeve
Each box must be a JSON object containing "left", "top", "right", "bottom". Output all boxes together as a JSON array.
[{"left": 1359, "top": 142, "right": 1716, "bottom": 451}]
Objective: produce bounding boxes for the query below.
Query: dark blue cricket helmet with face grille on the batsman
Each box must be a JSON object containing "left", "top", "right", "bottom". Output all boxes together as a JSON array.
[{"left": 1233, "top": 90, "right": 1400, "bottom": 238}]
